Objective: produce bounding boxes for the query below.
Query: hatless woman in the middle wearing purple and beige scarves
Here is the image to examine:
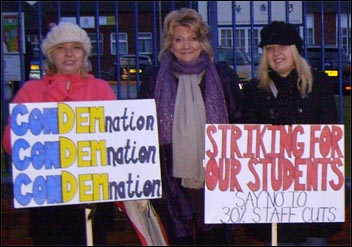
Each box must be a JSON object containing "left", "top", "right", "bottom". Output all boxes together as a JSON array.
[{"left": 139, "top": 8, "right": 241, "bottom": 245}]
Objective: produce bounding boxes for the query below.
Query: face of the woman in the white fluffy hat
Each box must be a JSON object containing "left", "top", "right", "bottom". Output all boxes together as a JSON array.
[{"left": 51, "top": 42, "right": 85, "bottom": 75}]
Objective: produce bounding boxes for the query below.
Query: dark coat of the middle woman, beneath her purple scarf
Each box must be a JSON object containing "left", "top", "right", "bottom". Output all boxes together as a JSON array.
[{"left": 138, "top": 64, "right": 242, "bottom": 244}]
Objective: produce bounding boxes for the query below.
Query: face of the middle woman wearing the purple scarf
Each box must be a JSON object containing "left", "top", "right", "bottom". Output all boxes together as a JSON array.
[{"left": 171, "top": 26, "right": 202, "bottom": 64}]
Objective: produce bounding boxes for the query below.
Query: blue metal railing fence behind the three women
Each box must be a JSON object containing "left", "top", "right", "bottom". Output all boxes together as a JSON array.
[{"left": 1, "top": 1, "right": 351, "bottom": 129}]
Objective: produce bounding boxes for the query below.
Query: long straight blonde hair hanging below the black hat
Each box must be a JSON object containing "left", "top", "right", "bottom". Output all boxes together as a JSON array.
[{"left": 257, "top": 45, "right": 313, "bottom": 96}]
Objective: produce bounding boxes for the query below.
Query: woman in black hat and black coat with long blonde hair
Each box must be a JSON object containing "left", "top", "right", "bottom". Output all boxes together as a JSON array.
[{"left": 243, "top": 21, "right": 342, "bottom": 245}]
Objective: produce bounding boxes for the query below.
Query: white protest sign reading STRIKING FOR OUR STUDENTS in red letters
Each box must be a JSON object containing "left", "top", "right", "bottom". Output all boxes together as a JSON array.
[{"left": 204, "top": 124, "right": 345, "bottom": 224}]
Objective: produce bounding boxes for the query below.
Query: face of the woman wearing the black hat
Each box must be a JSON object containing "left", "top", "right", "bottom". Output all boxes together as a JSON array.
[{"left": 265, "top": 44, "right": 295, "bottom": 77}]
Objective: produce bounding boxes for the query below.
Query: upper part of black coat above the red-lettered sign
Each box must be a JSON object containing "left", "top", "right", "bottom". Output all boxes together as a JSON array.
[{"left": 242, "top": 69, "right": 338, "bottom": 124}]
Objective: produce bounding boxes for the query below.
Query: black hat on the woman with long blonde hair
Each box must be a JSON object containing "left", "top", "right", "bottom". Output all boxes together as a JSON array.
[{"left": 259, "top": 21, "right": 303, "bottom": 51}]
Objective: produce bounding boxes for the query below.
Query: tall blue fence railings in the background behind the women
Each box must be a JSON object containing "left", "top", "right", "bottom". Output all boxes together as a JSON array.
[{"left": 1, "top": 1, "right": 351, "bottom": 127}]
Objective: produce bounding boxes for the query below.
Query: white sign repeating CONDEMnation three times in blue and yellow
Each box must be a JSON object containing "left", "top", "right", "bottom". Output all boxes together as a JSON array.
[{"left": 10, "top": 100, "right": 162, "bottom": 208}]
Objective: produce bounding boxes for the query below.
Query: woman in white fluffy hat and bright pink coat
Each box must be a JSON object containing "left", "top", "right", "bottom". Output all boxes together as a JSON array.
[{"left": 2, "top": 22, "right": 116, "bottom": 245}]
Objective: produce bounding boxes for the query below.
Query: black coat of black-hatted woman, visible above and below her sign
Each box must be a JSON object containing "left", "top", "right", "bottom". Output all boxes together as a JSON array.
[{"left": 242, "top": 69, "right": 342, "bottom": 242}]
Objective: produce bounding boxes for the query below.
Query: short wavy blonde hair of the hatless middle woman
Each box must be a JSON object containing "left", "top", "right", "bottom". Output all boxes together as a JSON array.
[{"left": 158, "top": 8, "right": 214, "bottom": 62}]
